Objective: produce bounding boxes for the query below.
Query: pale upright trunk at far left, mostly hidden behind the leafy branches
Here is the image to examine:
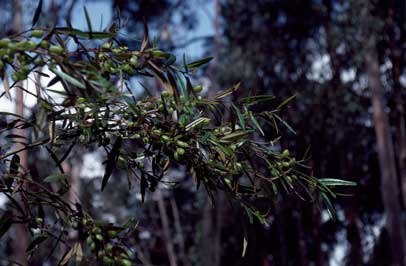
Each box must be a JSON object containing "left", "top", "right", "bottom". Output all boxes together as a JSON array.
[{"left": 12, "top": 0, "right": 28, "bottom": 266}]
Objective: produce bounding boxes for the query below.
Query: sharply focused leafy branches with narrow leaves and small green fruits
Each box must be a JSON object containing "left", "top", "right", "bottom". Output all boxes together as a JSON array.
[{"left": 0, "top": 14, "right": 352, "bottom": 265}]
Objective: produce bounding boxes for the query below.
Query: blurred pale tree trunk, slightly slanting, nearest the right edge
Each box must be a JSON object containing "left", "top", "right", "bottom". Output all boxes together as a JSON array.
[{"left": 365, "top": 34, "right": 405, "bottom": 266}]
